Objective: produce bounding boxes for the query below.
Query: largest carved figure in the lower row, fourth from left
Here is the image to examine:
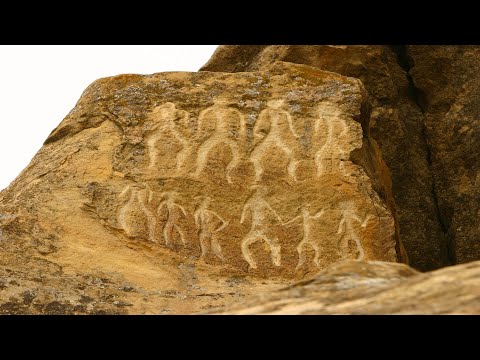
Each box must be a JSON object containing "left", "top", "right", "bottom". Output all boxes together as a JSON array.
[{"left": 240, "top": 188, "right": 283, "bottom": 269}]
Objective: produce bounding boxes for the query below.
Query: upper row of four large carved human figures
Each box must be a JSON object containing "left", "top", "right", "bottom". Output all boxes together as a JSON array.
[{"left": 146, "top": 99, "right": 349, "bottom": 183}]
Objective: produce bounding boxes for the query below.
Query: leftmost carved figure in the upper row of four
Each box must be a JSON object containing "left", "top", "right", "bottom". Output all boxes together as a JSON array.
[{"left": 146, "top": 102, "right": 193, "bottom": 171}]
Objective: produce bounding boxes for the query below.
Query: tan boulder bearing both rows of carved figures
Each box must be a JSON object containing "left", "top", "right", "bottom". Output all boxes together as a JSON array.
[{"left": 0, "top": 62, "right": 398, "bottom": 313}]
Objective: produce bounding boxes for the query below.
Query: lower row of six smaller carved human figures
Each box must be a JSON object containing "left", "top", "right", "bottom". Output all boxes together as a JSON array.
[{"left": 118, "top": 185, "right": 371, "bottom": 268}]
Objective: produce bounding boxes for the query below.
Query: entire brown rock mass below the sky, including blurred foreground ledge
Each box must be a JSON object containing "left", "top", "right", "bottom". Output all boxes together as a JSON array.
[{"left": 0, "top": 45, "right": 480, "bottom": 314}]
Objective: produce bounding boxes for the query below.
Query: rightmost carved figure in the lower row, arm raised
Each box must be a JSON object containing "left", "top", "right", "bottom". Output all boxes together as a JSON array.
[{"left": 337, "top": 201, "right": 372, "bottom": 260}]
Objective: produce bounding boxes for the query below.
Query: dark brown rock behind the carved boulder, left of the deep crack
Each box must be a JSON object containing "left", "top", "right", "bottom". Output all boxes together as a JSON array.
[{"left": 202, "top": 45, "right": 454, "bottom": 270}]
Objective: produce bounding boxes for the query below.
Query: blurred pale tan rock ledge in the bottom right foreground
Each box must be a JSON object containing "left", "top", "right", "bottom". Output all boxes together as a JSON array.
[{"left": 216, "top": 261, "right": 480, "bottom": 315}]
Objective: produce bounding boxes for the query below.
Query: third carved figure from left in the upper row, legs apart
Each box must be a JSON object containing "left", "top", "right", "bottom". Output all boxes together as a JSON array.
[{"left": 250, "top": 99, "right": 298, "bottom": 182}]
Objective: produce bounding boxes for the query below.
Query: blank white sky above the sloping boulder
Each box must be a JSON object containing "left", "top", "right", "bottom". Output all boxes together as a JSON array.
[{"left": 0, "top": 45, "right": 217, "bottom": 190}]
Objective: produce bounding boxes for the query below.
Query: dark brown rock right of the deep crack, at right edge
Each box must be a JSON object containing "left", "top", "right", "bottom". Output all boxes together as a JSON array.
[{"left": 407, "top": 46, "right": 480, "bottom": 263}]
